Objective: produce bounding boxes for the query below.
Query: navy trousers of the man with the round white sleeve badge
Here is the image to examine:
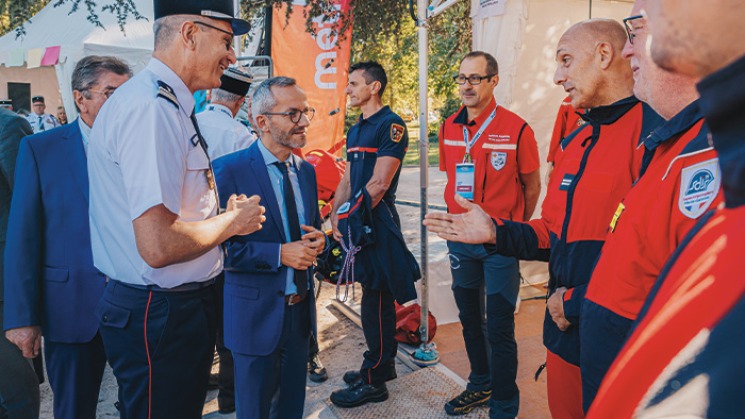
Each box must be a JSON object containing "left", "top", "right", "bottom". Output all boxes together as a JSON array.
[{"left": 579, "top": 299, "right": 633, "bottom": 413}]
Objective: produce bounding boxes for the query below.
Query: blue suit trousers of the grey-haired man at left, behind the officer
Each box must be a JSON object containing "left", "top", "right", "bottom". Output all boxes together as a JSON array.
[{"left": 44, "top": 333, "right": 106, "bottom": 419}]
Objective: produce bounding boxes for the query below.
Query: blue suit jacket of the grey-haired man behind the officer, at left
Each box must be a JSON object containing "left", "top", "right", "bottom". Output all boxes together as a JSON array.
[{"left": 3, "top": 120, "right": 106, "bottom": 343}]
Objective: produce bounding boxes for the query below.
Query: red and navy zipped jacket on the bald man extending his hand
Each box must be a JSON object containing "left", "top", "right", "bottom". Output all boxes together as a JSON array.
[{"left": 489, "top": 97, "right": 662, "bottom": 365}]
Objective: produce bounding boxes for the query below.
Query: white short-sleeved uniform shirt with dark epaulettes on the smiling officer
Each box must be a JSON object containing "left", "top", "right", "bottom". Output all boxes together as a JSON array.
[{"left": 88, "top": 58, "right": 222, "bottom": 288}]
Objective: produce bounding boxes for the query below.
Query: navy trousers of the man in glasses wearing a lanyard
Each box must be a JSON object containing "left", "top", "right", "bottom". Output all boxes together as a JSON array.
[{"left": 448, "top": 242, "right": 520, "bottom": 417}]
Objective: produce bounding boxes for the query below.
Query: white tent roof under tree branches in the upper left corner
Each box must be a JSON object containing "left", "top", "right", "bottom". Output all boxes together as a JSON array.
[{"left": 0, "top": 0, "right": 153, "bottom": 117}]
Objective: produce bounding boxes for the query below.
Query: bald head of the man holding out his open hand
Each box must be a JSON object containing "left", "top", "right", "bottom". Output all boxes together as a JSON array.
[{"left": 554, "top": 19, "right": 634, "bottom": 108}]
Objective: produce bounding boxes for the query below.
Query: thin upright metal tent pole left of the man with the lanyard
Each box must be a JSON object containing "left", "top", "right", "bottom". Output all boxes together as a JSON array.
[{"left": 411, "top": 0, "right": 440, "bottom": 366}]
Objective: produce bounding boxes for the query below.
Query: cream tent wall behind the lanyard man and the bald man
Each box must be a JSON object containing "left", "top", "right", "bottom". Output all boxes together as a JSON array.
[{"left": 429, "top": 0, "right": 633, "bottom": 324}]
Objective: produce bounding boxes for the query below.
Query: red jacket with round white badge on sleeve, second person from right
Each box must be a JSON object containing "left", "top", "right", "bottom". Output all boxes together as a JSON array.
[{"left": 583, "top": 101, "right": 722, "bottom": 322}]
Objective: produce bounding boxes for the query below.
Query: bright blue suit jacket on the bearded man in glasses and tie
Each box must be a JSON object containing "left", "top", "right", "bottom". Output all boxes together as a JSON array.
[{"left": 213, "top": 141, "right": 321, "bottom": 356}]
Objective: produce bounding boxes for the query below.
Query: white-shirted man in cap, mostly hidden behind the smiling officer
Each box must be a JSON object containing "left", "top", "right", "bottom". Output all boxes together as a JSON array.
[{"left": 197, "top": 68, "right": 256, "bottom": 160}]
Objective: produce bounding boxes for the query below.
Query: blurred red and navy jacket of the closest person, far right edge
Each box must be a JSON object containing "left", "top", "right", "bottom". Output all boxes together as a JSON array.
[{"left": 588, "top": 57, "right": 745, "bottom": 418}]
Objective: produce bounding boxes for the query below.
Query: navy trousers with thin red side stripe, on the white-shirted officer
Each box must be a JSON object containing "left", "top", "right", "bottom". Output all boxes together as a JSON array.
[{"left": 96, "top": 281, "right": 217, "bottom": 419}]
